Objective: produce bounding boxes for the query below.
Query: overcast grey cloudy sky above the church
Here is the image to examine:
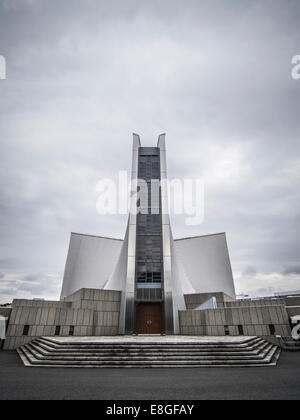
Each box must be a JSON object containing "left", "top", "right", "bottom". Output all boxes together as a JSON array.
[{"left": 0, "top": 0, "right": 300, "bottom": 303}]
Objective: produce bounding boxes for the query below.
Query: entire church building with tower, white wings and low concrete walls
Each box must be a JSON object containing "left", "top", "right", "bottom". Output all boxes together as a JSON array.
[{"left": 0, "top": 134, "right": 300, "bottom": 349}]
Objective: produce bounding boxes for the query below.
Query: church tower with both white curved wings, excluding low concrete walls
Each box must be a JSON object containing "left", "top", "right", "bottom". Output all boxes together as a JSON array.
[{"left": 61, "top": 134, "right": 235, "bottom": 334}]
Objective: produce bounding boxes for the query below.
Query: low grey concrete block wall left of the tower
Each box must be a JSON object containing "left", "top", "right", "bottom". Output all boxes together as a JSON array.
[{"left": 4, "top": 289, "right": 120, "bottom": 350}]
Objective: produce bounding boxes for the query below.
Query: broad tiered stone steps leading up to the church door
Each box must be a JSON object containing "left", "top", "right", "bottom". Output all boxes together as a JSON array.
[{"left": 18, "top": 337, "right": 280, "bottom": 368}]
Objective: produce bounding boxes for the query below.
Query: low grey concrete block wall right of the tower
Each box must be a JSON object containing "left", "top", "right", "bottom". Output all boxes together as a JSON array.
[{"left": 179, "top": 305, "right": 291, "bottom": 339}]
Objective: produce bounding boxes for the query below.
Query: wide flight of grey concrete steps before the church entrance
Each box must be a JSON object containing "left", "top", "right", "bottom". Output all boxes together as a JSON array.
[{"left": 17, "top": 337, "right": 280, "bottom": 368}]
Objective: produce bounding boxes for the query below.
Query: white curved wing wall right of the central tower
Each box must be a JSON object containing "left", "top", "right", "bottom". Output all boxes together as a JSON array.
[{"left": 174, "top": 233, "right": 235, "bottom": 298}]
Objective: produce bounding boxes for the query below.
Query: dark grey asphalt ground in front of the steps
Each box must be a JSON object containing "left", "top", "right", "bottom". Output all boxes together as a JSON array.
[{"left": 0, "top": 351, "right": 300, "bottom": 400}]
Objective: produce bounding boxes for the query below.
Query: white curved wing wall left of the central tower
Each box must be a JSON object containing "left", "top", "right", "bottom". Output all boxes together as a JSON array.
[{"left": 61, "top": 233, "right": 123, "bottom": 299}]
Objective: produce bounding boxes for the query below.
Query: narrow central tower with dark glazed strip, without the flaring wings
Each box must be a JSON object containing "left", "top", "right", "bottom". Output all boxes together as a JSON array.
[{"left": 124, "top": 134, "right": 173, "bottom": 334}]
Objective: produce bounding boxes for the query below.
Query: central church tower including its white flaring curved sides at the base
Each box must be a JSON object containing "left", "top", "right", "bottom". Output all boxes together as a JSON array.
[{"left": 105, "top": 134, "right": 194, "bottom": 334}]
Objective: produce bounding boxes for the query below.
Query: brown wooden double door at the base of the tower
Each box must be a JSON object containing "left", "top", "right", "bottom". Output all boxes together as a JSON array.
[{"left": 135, "top": 302, "right": 164, "bottom": 334}]
